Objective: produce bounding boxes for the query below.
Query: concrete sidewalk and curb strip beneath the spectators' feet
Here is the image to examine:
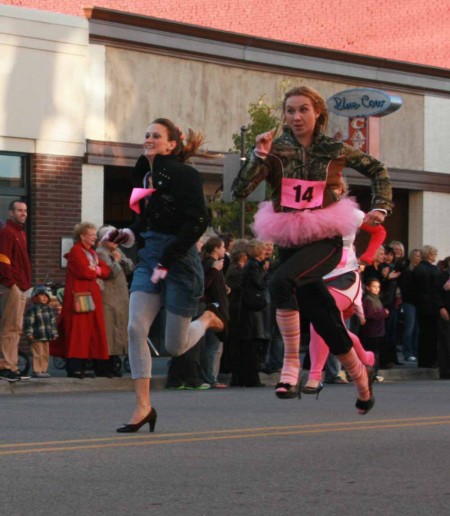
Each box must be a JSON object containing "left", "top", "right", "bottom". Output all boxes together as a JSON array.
[{"left": 0, "top": 357, "right": 439, "bottom": 395}]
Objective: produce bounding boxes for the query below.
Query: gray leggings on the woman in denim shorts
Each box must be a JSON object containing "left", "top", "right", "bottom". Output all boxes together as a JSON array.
[{"left": 128, "top": 292, "right": 206, "bottom": 380}]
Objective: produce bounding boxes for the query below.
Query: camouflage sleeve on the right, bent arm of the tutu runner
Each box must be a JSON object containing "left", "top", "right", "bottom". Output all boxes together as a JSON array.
[{"left": 344, "top": 145, "right": 393, "bottom": 214}]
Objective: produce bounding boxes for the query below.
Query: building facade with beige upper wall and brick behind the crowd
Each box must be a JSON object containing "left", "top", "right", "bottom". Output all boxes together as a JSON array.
[{"left": 0, "top": 0, "right": 450, "bottom": 281}]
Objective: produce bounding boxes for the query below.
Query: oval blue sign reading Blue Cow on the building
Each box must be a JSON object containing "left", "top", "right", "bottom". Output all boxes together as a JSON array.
[{"left": 327, "top": 88, "right": 403, "bottom": 118}]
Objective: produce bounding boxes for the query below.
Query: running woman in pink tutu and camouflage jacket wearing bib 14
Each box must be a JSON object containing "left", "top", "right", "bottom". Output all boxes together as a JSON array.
[{"left": 233, "top": 86, "right": 392, "bottom": 414}]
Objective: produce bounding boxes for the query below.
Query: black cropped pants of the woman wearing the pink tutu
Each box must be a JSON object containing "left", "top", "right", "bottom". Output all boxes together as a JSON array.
[{"left": 270, "top": 237, "right": 352, "bottom": 355}]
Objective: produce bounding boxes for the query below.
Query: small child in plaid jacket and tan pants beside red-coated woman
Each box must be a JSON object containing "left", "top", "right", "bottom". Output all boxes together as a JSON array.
[{"left": 24, "top": 286, "right": 58, "bottom": 378}]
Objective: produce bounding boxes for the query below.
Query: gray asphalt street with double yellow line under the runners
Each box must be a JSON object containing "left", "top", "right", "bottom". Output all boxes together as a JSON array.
[{"left": 0, "top": 380, "right": 450, "bottom": 516}]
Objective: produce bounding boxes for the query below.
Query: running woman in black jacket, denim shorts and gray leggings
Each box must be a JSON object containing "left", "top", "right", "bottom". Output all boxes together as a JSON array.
[{"left": 107, "top": 118, "right": 224, "bottom": 433}]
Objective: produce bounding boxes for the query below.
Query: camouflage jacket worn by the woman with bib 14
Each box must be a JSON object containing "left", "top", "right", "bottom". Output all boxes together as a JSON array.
[{"left": 233, "top": 126, "right": 392, "bottom": 214}]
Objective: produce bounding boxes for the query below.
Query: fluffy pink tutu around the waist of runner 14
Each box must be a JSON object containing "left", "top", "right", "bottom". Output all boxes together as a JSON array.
[{"left": 252, "top": 197, "right": 361, "bottom": 247}]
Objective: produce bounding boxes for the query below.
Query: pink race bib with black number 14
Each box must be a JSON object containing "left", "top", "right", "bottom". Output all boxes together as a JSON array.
[{"left": 281, "top": 178, "right": 327, "bottom": 210}]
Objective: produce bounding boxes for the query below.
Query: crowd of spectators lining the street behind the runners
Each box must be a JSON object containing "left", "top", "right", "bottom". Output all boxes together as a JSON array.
[{"left": 0, "top": 202, "right": 450, "bottom": 384}]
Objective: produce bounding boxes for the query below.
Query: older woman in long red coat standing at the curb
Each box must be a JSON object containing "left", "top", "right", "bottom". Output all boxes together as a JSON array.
[{"left": 59, "top": 222, "right": 111, "bottom": 379}]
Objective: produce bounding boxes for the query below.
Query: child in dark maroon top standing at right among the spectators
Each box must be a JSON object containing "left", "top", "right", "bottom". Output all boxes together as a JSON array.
[{"left": 360, "top": 278, "right": 389, "bottom": 370}]
